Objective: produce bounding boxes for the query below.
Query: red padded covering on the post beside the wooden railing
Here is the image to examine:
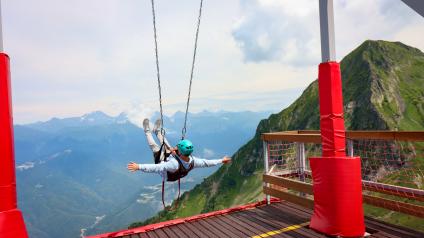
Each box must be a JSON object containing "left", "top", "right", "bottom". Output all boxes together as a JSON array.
[{"left": 310, "top": 62, "right": 365, "bottom": 237}]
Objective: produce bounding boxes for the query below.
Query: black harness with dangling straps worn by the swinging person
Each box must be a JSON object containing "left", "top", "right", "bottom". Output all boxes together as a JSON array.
[{"left": 154, "top": 143, "right": 194, "bottom": 210}]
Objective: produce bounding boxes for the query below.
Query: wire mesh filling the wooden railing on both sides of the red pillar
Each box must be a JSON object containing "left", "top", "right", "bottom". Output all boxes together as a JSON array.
[{"left": 267, "top": 140, "right": 424, "bottom": 189}]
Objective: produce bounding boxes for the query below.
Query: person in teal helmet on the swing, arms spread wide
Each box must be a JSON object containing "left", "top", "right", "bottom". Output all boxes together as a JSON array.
[{"left": 127, "top": 119, "right": 231, "bottom": 181}]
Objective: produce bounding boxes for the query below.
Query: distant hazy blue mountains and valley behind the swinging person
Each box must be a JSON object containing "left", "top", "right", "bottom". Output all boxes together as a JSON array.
[{"left": 14, "top": 111, "right": 268, "bottom": 238}]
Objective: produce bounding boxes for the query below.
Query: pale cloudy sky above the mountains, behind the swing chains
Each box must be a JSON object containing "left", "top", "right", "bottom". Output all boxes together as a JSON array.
[{"left": 1, "top": 0, "right": 424, "bottom": 123}]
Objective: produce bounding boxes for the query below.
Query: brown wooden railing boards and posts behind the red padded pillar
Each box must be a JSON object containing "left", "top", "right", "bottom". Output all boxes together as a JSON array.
[{"left": 262, "top": 131, "right": 424, "bottom": 218}]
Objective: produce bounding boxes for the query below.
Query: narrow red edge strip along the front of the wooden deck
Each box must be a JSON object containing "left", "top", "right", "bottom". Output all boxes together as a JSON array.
[{"left": 86, "top": 198, "right": 280, "bottom": 238}]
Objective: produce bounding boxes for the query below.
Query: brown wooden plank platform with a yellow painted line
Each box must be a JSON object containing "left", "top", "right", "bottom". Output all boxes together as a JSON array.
[{"left": 96, "top": 202, "right": 424, "bottom": 238}]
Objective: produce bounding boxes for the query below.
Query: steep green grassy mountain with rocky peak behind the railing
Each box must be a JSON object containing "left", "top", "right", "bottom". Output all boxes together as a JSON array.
[{"left": 136, "top": 40, "right": 424, "bottom": 229}]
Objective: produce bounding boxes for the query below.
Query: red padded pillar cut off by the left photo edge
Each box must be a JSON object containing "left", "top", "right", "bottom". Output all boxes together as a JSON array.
[{"left": 0, "top": 53, "right": 28, "bottom": 238}]
